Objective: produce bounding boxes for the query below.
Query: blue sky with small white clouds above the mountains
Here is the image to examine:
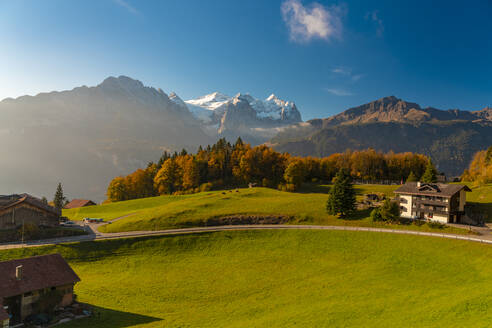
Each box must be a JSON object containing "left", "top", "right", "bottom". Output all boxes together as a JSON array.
[{"left": 0, "top": 0, "right": 492, "bottom": 119}]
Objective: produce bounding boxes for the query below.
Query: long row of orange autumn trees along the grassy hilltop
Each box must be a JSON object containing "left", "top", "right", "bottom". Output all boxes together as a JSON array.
[{"left": 107, "top": 138, "right": 428, "bottom": 202}]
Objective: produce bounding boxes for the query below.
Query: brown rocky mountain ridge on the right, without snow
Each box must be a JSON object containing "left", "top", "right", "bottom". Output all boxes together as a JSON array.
[{"left": 270, "top": 96, "right": 492, "bottom": 176}]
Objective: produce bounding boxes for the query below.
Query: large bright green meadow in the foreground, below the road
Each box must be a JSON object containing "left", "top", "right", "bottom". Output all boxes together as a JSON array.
[{"left": 0, "top": 230, "right": 492, "bottom": 328}]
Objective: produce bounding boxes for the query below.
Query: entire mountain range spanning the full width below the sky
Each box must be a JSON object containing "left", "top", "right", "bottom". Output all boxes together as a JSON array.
[{"left": 0, "top": 76, "right": 492, "bottom": 201}]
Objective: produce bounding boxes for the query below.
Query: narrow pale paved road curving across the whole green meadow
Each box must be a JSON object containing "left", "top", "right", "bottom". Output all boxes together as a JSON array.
[{"left": 0, "top": 225, "right": 492, "bottom": 249}]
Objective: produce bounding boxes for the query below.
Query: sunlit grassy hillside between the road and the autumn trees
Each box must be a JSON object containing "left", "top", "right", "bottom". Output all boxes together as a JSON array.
[{"left": 64, "top": 185, "right": 467, "bottom": 233}]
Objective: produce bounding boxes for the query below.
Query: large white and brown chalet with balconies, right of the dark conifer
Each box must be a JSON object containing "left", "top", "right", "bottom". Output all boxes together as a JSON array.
[{"left": 395, "top": 182, "right": 471, "bottom": 223}]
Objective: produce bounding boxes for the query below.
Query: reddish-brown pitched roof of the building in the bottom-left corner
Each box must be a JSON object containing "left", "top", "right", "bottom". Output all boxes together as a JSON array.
[{"left": 0, "top": 254, "right": 80, "bottom": 298}]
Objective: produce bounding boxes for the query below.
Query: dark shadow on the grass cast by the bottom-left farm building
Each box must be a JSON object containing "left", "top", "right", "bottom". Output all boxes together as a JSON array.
[{"left": 59, "top": 304, "right": 163, "bottom": 328}]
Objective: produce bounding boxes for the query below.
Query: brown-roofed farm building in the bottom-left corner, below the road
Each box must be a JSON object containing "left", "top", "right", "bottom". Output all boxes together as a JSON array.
[{"left": 0, "top": 254, "right": 80, "bottom": 328}]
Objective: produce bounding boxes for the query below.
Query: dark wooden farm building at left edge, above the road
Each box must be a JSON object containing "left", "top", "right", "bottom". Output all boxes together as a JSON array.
[{"left": 0, "top": 194, "right": 61, "bottom": 229}]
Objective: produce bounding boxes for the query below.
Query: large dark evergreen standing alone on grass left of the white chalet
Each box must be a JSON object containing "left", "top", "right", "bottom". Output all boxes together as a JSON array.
[{"left": 326, "top": 169, "right": 355, "bottom": 218}]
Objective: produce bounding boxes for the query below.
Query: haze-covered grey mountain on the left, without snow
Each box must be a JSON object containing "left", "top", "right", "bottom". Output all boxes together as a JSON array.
[{"left": 0, "top": 77, "right": 214, "bottom": 201}]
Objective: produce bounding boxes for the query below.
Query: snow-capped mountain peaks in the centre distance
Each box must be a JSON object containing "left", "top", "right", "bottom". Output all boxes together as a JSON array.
[{"left": 185, "top": 92, "right": 302, "bottom": 143}]
